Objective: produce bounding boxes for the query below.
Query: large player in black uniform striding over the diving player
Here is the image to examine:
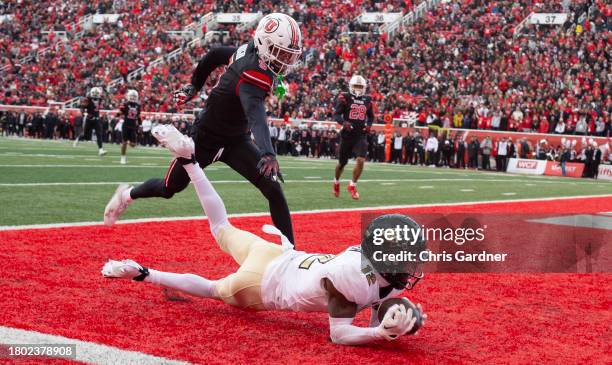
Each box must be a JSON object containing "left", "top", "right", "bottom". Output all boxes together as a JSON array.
[{"left": 104, "top": 13, "right": 302, "bottom": 242}]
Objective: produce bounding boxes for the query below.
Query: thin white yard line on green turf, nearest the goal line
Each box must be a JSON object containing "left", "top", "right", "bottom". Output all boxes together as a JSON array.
[{"left": 0, "top": 177, "right": 608, "bottom": 189}]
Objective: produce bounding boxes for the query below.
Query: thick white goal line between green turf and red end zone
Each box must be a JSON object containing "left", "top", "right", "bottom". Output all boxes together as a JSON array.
[{"left": 0, "top": 194, "right": 612, "bottom": 231}]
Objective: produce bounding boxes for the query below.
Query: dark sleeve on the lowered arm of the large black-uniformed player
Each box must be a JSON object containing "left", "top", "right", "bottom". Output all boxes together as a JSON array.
[{"left": 238, "top": 82, "right": 276, "bottom": 156}]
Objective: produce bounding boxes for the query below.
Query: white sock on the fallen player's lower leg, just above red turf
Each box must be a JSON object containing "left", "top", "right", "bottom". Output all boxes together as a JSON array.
[{"left": 144, "top": 269, "right": 218, "bottom": 299}]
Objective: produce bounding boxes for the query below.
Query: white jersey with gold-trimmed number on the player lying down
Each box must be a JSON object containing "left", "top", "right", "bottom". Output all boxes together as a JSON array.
[{"left": 261, "top": 246, "right": 402, "bottom": 312}]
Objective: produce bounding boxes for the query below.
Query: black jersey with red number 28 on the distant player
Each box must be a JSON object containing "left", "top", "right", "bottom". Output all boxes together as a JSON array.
[{"left": 334, "top": 93, "right": 374, "bottom": 135}]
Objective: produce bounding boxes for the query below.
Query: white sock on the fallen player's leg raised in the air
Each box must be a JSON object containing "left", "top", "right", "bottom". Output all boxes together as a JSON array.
[{"left": 183, "top": 162, "right": 229, "bottom": 238}]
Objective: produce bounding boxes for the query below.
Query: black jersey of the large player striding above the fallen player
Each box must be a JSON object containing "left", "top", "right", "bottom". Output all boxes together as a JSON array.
[{"left": 192, "top": 41, "right": 275, "bottom": 154}]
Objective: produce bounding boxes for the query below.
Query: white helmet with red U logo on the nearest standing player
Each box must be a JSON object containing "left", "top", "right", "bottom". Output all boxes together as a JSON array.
[{"left": 253, "top": 13, "right": 302, "bottom": 75}]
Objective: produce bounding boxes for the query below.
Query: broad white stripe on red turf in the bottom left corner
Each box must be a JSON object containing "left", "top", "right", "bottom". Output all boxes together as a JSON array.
[{"left": 0, "top": 326, "right": 191, "bottom": 365}]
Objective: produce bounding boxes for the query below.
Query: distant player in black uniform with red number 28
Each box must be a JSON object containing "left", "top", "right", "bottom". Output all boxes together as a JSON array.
[{"left": 333, "top": 75, "right": 374, "bottom": 200}]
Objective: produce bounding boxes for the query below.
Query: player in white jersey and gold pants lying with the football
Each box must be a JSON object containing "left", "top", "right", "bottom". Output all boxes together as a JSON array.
[{"left": 102, "top": 126, "right": 426, "bottom": 345}]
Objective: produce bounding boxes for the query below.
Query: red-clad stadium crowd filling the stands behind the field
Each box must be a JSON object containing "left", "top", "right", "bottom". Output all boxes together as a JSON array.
[{"left": 0, "top": 0, "right": 612, "bottom": 140}]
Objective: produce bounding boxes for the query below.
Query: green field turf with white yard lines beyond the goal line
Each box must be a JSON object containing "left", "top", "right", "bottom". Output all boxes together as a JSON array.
[{"left": 0, "top": 138, "right": 612, "bottom": 226}]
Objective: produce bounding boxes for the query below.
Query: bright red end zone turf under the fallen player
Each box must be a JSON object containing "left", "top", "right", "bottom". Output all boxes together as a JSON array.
[{"left": 0, "top": 197, "right": 612, "bottom": 364}]
